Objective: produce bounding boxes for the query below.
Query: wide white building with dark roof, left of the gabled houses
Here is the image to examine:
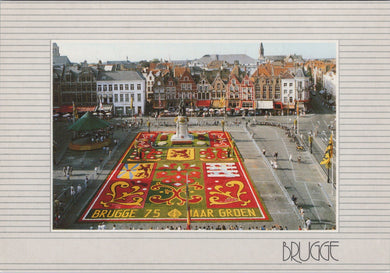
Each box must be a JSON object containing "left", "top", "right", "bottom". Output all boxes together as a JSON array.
[{"left": 96, "top": 71, "right": 145, "bottom": 116}]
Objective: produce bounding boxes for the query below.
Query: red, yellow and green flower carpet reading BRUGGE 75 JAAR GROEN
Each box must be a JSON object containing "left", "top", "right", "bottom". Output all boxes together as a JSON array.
[{"left": 80, "top": 131, "right": 271, "bottom": 222}]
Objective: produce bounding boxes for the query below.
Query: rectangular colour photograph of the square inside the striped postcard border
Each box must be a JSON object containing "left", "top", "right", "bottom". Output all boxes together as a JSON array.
[{"left": 51, "top": 40, "right": 338, "bottom": 232}]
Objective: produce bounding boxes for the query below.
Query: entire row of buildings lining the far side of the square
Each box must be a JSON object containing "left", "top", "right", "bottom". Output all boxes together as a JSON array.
[{"left": 53, "top": 42, "right": 335, "bottom": 115}]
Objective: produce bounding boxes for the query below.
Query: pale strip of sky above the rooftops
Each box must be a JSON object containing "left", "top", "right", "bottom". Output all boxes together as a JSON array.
[{"left": 53, "top": 40, "right": 337, "bottom": 63}]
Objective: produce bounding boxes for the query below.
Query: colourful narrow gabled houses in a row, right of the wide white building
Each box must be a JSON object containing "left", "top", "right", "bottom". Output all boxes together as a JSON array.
[{"left": 145, "top": 63, "right": 310, "bottom": 115}]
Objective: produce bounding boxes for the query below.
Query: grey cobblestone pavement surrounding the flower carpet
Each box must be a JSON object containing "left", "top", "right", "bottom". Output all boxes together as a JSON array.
[{"left": 53, "top": 117, "right": 336, "bottom": 230}]
